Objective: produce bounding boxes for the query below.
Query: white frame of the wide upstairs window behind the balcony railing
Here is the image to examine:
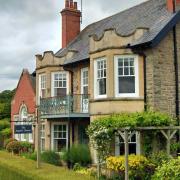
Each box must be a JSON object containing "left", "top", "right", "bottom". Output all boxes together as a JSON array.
[{"left": 51, "top": 71, "right": 69, "bottom": 97}]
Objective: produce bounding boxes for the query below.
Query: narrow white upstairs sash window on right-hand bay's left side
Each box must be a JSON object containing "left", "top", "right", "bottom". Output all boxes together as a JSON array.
[{"left": 94, "top": 58, "right": 107, "bottom": 98}]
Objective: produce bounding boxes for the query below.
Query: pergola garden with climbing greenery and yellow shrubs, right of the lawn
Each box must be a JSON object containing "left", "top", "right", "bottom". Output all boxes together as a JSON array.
[{"left": 88, "top": 112, "right": 180, "bottom": 180}]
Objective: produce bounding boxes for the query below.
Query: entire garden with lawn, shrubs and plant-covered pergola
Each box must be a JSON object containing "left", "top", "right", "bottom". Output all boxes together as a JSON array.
[{"left": 0, "top": 112, "right": 180, "bottom": 180}]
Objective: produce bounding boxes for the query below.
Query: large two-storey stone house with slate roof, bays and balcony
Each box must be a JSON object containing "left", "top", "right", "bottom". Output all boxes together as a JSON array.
[{"left": 36, "top": 0, "right": 180, "bottom": 154}]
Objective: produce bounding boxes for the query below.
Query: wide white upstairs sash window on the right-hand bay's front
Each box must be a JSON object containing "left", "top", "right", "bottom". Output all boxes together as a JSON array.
[{"left": 114, "top": 55, "right": 139, "bottom": 97}]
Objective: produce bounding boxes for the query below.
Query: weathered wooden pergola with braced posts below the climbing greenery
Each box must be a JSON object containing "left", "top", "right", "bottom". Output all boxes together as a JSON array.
[{"left": 117, "top": 126, "right": 180, "bottom": 180}]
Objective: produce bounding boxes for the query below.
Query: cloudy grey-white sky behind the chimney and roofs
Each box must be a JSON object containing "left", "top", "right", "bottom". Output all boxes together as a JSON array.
[{"left": 0, "top": 0, "right": 145, "bottom": 92}]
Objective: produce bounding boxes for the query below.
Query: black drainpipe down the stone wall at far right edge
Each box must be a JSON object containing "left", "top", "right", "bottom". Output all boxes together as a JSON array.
[{"left": 173, "top": 0, "right": 180, "bottom": 141}]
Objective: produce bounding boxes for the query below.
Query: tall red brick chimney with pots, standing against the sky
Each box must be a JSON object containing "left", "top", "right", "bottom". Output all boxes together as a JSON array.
[{"left": 61, "top": 0, "right": 81, "bottom": 48}]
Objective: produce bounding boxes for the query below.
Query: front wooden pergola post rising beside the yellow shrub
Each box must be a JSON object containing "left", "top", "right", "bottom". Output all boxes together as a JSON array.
[{"left": 124, "top": 129, "right": 129, "bottom": 180}]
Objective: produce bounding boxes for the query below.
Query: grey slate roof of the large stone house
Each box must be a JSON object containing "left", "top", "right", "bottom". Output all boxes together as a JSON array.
[{"left": 55, "top": 0, "right": 179, "bottom": 64}]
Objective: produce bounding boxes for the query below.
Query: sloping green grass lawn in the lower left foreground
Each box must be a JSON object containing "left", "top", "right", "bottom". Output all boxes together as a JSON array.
[{"left": 0, "top": 151, "right": 93, "bottom": 180}]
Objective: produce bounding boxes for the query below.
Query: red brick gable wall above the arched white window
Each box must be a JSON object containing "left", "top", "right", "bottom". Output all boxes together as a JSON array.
[{"left": 11, "top": 70, "right": 36, "bottom": 134}]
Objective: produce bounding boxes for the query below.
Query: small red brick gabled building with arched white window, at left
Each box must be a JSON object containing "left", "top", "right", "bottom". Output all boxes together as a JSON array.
[{"left": 11, "top": 69, "right": 36, "bottom": 143}]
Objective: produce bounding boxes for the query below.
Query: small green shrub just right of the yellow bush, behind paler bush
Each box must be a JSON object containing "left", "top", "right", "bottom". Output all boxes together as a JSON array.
[{"left": 149, "top": 151, "right": 171, "bottom": 167}]
